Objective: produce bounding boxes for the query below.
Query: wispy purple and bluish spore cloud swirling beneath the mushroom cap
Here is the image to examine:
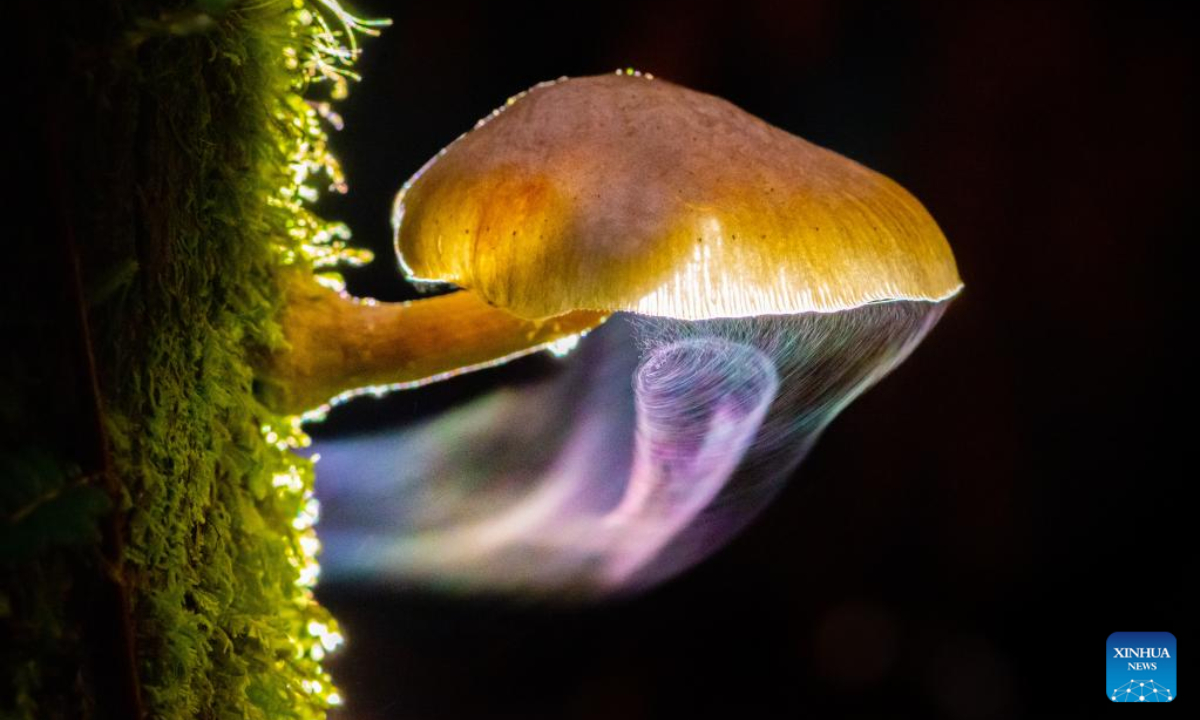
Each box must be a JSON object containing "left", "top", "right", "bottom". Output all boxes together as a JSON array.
[{"left": 318, "top": 301, "right": 946, "bottom": 596}]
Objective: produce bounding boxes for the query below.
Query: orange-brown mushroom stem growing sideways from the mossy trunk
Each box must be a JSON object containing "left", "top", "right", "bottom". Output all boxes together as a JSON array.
[{"left": 258, "top": 272, "right": 607, "bottom": 414}]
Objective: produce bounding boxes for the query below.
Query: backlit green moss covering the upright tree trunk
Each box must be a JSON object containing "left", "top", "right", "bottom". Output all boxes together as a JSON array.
[{"left": 0, "top": 0, "right": 381, "bottom": 719}]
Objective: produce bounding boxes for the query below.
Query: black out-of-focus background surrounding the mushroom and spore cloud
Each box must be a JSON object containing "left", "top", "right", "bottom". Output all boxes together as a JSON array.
[{"left": 311, "top": 0, "right": 1200, "bottom": 720}]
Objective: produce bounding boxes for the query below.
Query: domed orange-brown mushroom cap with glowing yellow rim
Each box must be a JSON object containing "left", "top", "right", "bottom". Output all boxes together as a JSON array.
[{"left": 394, "top": 73, "right": 962, "bottom": 320}]
